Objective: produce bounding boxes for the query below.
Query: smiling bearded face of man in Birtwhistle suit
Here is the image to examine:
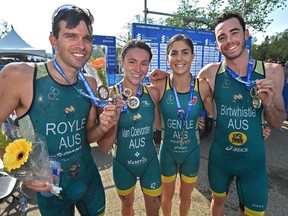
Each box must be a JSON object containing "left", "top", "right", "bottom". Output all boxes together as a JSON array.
[{"left": 215, "top": 18, "right": 249, "bottom": 60}]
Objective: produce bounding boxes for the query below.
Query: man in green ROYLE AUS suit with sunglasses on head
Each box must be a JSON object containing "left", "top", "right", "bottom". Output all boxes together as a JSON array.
[{"left": 0, "top": 5, "right": 117, "bottom": 216}]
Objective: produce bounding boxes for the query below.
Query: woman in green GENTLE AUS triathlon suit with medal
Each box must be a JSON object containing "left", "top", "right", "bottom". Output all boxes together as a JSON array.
[{"left": 148, "top": 34, "right": 213, "bottom": 216}]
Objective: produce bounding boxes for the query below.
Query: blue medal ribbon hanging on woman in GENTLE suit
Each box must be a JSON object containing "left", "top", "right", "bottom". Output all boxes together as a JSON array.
[{"left": 171, "top": 76, "right": 194, "bottom": 129}]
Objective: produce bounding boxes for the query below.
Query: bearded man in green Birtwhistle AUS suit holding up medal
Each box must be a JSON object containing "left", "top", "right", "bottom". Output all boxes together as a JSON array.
[{"left": 199, "top": 13, "right": 286, "bottom": 216}]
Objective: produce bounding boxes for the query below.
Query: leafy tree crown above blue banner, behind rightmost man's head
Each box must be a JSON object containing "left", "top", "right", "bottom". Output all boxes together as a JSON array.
[{"left": 165, "top": 0, "right": 287, "bottom": 32}]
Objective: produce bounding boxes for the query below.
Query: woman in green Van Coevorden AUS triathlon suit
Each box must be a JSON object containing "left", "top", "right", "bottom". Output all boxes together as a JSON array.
[{"left": 98, "top": 40, "right": 162, "bottom": 216}]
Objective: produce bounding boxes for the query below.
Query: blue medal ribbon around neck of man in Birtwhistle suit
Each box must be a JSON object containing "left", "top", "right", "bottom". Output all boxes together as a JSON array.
[{"left": 225, "top": 56, "right": 256, "bottom": 90}]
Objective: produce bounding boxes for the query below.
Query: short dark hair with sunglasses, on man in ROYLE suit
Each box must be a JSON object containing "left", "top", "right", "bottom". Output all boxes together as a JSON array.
[{"left": 52, "top": 5, "right": 94, "bottom": 38}]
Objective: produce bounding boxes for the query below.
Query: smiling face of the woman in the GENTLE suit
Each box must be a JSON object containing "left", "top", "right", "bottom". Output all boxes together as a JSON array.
[{"left": 167, "top": 40, "right": 194, "bottom": 74}]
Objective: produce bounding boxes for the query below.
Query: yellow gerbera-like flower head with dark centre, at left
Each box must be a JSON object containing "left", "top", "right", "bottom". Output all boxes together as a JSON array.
[{"left": 3, "top": 139, "right": 32, "bottom": 172}]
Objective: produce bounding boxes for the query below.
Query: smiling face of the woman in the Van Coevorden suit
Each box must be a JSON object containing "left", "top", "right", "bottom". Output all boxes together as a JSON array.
[{"left": 120, "top": 47, "right": 150, "bottom": 85}]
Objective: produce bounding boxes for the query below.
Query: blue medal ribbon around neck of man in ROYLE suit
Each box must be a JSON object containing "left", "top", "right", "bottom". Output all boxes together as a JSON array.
[{"left": 53, "top": 58, "right": 108, "bottom": 108}]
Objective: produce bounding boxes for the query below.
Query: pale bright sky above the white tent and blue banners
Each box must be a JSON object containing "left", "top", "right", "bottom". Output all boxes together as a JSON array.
[{"left": 0, "top": 0, "right": 288, "bottom": 52}]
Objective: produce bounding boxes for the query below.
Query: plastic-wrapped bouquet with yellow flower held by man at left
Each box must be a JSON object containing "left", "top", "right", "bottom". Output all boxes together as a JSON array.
[{"left": 0, "top": 123, "right": 61, "bottom": 196}]
